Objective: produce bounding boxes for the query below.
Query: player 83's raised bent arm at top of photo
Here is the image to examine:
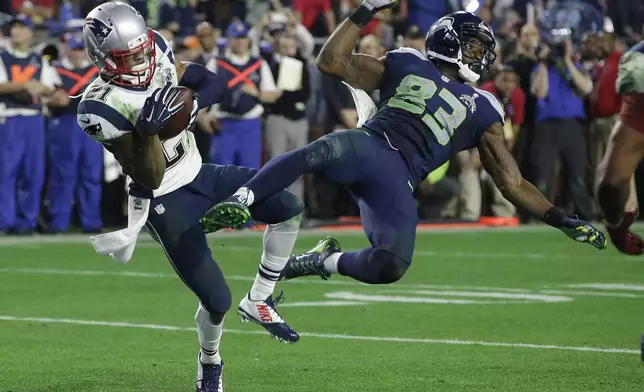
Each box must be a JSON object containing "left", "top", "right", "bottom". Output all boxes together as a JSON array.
[{"left": 316, "top": 0, "right": 396, "bottom": 90}]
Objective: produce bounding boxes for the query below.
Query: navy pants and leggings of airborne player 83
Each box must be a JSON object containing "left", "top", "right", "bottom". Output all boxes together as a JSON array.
[{"left": 245, "top": 129, "right": 418, "bottom": 268}]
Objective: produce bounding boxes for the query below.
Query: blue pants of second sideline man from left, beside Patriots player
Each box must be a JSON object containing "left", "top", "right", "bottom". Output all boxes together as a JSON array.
[{"left": 47, "top": 114, "right": 103, "bottom": 232}]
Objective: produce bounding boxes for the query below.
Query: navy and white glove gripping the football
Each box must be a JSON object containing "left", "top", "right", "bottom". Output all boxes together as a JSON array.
[{"left": 136, "top": 83, "right": 184, "bottom": 136}]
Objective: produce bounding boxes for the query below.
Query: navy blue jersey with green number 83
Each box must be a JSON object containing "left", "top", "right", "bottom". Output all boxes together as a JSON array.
[{"left": 364, "top": 48, "right": 504, "bottom": 182}]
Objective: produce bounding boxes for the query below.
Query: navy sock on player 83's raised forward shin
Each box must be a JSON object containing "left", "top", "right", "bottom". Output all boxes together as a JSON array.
[{"left": 244, "top": 143, "right": 320, "bottom": 201}]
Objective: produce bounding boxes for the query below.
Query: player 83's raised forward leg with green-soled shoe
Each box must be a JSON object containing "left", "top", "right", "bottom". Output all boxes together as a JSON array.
[{"left": 204, "top": 130, "right": 372, "bottom": 228}]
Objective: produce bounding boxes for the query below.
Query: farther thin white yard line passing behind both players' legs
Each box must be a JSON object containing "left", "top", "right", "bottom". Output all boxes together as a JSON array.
[{"left": 0, "top": 268, "right": 530, "bottom": 293}]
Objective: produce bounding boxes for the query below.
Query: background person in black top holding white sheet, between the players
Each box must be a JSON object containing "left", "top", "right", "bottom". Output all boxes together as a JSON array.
[{"left": 264, "top": 34, "right": 311, "bottom": 199}]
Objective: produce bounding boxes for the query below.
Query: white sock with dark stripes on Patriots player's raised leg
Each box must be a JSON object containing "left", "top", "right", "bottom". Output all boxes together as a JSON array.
[{"left": 250, "top": 215, "right": 301, "bottom": 301}]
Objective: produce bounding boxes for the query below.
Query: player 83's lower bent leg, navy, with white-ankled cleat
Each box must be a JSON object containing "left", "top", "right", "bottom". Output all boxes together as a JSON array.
[{"left": 281, "top": 145, "right": 418, "bottom": 284}]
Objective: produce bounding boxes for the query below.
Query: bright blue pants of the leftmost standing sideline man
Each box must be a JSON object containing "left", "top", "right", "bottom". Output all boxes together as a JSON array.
[{"left": 0, "top": 115, "right": 45, "bottom": 232}]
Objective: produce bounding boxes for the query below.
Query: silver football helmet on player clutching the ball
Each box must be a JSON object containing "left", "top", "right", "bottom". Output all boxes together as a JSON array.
[{"left": 83, "top": 1, "right": 156, "bottom": 86}]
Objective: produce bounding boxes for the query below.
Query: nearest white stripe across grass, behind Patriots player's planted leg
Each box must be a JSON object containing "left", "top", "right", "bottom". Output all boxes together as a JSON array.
[{"left": 0, "top": 316, "right": 640, "bottom": 355}]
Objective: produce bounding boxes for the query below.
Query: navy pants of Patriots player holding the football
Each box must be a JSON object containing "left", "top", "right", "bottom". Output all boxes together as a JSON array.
[{"left": 146, "top": 164, "right": 304, "bottom": 315}]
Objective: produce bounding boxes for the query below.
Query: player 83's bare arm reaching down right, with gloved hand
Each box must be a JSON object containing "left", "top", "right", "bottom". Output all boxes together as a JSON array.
[{"left": 478, "top": 123, "right": 606, "bottom": 249}]
